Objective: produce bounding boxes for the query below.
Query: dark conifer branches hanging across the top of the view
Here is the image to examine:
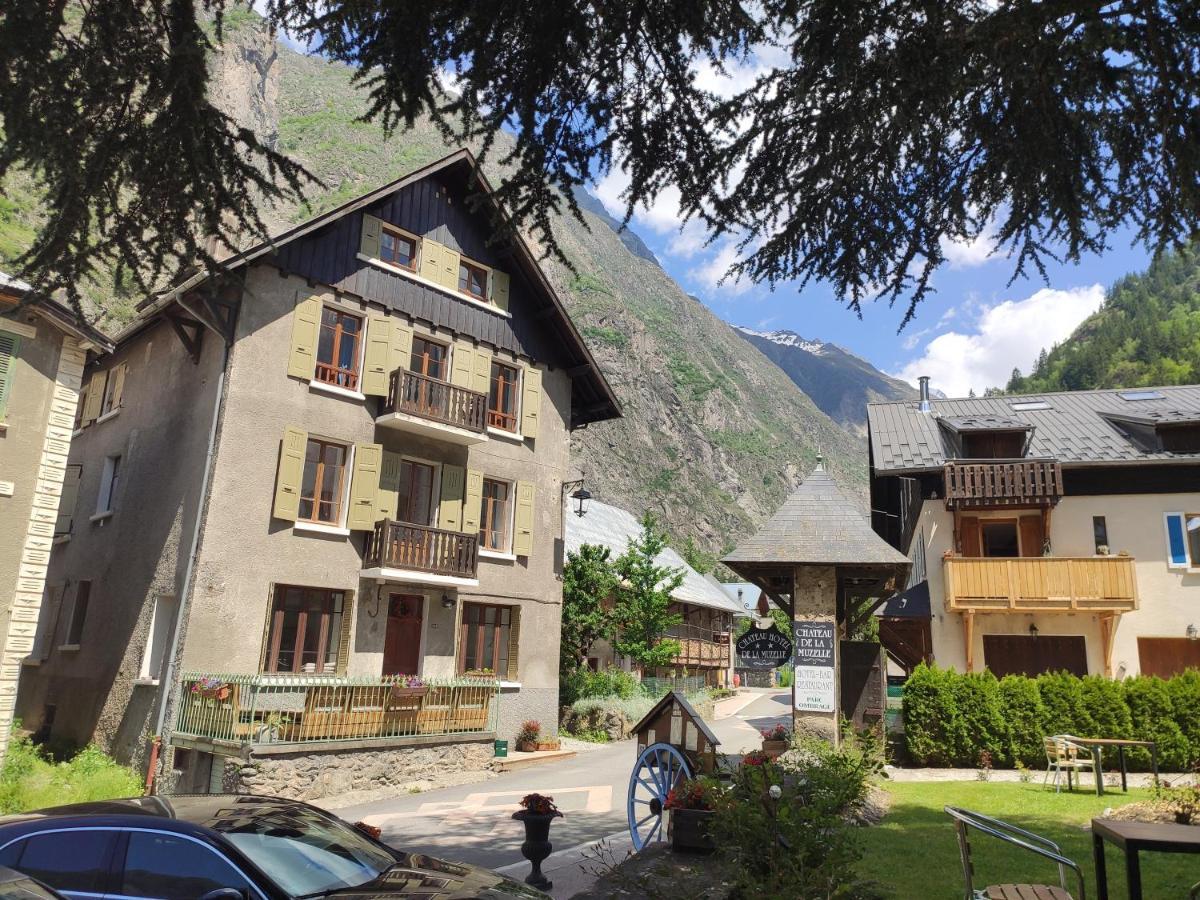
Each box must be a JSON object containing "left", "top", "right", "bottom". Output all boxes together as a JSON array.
[{"left": 0, "top": 0, "right": 1200, "bottom": 316}]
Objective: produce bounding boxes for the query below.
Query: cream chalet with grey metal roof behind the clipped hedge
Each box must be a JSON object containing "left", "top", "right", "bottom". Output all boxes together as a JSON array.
[{"left": 868, "top": 379, "right": 1200, "bottom": 678}]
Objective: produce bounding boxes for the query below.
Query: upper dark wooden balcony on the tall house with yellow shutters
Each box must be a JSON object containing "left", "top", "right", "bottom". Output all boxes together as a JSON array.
[{"left": 376, "top": 368, "right": 487, "bottom": 444}]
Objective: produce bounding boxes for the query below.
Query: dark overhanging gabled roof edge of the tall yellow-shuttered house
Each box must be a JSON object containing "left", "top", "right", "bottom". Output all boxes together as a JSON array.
[{"left": 132, "top": 148, "right": 622, "bottom": 426}]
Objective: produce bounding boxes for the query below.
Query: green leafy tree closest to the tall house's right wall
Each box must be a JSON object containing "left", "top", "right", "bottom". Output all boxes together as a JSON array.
[{"left": 558, "top": 544, "right": 617, "bottom": 677}]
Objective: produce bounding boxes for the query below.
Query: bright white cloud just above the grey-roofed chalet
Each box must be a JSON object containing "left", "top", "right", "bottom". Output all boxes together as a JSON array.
[{"left": 895, "top": 284, "right": 1104, "bottom": 397}]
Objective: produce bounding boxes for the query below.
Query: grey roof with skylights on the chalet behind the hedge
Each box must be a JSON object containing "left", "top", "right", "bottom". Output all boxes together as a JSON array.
[{"left": 866, "top": 384, "right": 1200, "bottom": 474}]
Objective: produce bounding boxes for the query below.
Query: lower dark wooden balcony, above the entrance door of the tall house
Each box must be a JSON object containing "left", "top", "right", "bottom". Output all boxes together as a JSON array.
[{"left": 361, "top": 520, "right": 479, "bottom": 587}]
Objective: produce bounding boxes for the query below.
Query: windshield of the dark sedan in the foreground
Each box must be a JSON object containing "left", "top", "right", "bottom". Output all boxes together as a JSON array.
[{"left": 215, "top": 806, "right": 396, "bottom": 896}]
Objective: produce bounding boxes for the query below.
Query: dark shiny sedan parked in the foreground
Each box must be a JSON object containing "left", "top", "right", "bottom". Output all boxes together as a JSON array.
[{"left": 0, "top": 794, "right": 545, "bottom": 900}]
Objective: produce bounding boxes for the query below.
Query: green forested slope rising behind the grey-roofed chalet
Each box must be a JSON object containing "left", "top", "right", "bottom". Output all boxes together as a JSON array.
[{"left": 1006, "top": 245, "right": 1200, "bottom": 394}]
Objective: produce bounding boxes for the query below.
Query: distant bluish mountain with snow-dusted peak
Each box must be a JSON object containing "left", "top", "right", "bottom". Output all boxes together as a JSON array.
[{"left": 733, "top": 325, "right": 917, "bottom": 436}]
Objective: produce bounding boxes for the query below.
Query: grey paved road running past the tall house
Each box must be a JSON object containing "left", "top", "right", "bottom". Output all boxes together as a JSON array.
[{"left": 336, "top": 690, "right": 790, "bottom": 883}]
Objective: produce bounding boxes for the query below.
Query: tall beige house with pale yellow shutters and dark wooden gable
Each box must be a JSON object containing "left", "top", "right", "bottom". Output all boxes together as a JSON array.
[{"left": 19, "top": 151, "right": 619, "bottom": 797}]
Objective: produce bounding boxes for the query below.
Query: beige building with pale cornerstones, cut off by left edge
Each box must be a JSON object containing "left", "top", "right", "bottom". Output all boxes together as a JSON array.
[{"left": 0, "top": 272, "right": 113, "bottom": 761}]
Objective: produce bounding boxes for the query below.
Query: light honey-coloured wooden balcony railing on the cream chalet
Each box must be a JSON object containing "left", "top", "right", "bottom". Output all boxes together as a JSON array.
[{"left": 943, "top": 557, "right": 1138, "bottom": 612}]
